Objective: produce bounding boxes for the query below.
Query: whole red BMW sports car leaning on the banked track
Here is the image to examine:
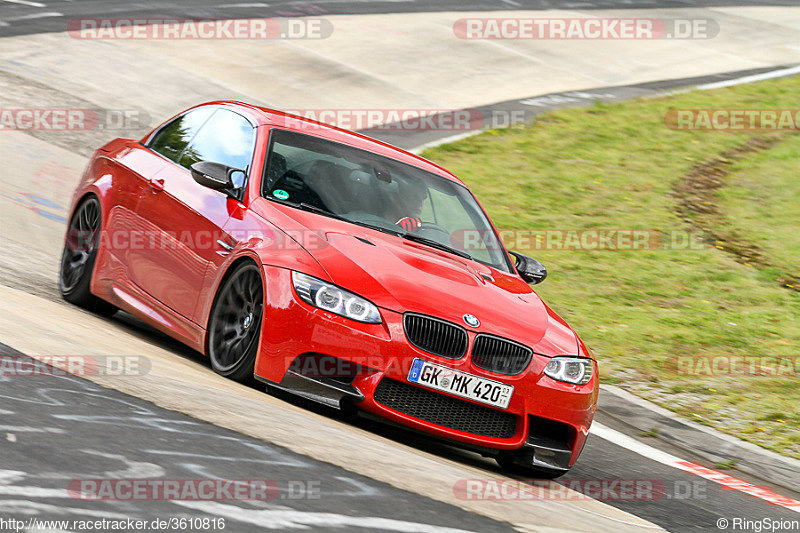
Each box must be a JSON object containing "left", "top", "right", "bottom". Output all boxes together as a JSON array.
[{"left": 60, "top": 102, "right": 598, "bottom": 477}]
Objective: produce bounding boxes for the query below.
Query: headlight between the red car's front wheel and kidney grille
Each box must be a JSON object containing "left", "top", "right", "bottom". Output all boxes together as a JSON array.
[{"left": 292, "top": 272, "right": 381, "bottom": 324}]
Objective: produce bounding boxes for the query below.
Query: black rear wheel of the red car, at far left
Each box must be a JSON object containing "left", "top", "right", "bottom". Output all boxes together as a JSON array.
[{"left": 58, "top": 196, "right": 117, "bottom": 317}]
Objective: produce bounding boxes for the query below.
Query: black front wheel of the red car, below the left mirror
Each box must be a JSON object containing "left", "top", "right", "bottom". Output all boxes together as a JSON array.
[{"left": 208, "top": 262, "right": 264, "bottom": 383}]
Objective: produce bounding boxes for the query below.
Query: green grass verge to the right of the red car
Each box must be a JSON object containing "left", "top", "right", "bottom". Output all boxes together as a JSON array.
[{"left": 423, "top": 77, "right": 800, "bottom": 457}]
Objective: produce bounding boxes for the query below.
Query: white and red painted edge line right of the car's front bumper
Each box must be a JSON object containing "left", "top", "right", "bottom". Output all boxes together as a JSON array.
[{"left": 590, "top": 422, "right": 800, "bottom": 513}]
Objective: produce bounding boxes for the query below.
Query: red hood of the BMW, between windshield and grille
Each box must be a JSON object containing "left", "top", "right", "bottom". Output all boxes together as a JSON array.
[{"left": 253, "top": 203, "right": 578, "bottom": 356}]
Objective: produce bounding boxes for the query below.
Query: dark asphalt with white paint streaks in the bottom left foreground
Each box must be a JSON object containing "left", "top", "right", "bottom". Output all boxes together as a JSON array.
[{"left": 0, "top": 344, "right": 511, "bottom": 533}]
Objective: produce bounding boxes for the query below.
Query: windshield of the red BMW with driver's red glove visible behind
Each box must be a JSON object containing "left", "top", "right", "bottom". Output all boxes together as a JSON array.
[{"left": 262, "top": 130, "right": 509, "bottom": 272}]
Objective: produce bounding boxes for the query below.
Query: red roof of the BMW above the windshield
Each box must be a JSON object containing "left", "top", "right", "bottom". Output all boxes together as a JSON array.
[{"left": 195, "top": 100, "right": 464, "bottom": 185}]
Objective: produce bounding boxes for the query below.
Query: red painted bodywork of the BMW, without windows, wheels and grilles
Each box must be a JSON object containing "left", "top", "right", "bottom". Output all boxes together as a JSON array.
[{"left": 67, "top": 102, "right": 599, "bottom": 465}]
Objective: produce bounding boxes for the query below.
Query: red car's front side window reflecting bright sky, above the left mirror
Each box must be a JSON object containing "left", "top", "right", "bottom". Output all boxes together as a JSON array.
[{"left": 179, "top": 109, "right": 256, "bottom": 186}]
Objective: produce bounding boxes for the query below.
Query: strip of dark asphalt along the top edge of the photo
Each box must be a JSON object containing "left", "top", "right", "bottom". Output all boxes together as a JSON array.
[{"left": 0, "top": 0, "right": 797, "bottom": 37}]
